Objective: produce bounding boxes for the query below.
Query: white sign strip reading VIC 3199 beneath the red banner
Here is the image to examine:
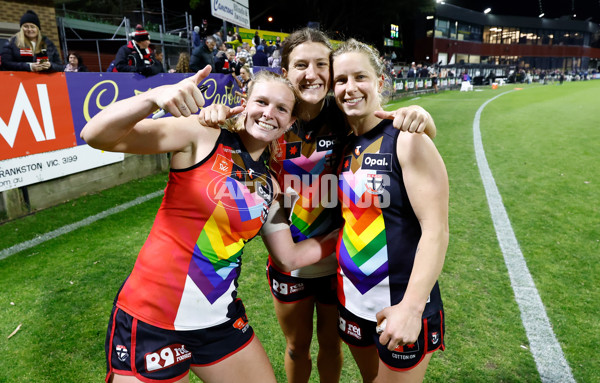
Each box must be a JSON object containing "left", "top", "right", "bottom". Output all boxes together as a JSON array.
[{"left": 0, "top": 145, "right": 125, "bottom": 192}]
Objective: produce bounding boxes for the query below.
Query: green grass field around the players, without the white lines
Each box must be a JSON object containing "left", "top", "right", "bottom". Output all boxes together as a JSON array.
[{"left": 0, "top": 81, "right": 600, "bottom": 383}]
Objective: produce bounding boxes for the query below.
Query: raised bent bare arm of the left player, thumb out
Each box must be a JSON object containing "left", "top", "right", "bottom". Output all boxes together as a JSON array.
[{"left": 81, "top": 67, "right": 212, "bottom": 154}]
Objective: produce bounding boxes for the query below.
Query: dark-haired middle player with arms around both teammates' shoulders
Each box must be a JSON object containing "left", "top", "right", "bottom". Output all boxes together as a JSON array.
[{"left": 200, "top": 28, "right": 436, "bottom": 383}]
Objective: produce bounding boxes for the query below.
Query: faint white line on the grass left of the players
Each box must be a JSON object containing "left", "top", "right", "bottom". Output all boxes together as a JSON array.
[{"left": 0, "top": 190, "right": 164, "bottom": 260}]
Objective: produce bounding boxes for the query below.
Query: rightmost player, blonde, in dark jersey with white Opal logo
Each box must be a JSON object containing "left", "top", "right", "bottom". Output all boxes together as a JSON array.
[{"left": 332, "top": 40, "right": 449, "bottom": 382}]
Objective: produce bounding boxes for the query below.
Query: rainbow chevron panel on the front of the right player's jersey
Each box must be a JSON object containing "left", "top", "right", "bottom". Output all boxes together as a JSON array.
[{"left": 338, "top": 170, "right": 388, "bottom": 294}]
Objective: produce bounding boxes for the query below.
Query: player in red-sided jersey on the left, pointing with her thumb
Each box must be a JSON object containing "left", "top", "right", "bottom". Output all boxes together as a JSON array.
[{"left": 81, "top": 66, "right": 326, "bottom": 383}]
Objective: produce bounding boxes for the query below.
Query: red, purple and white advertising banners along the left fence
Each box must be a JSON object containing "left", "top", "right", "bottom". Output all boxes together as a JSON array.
[{"left": 0, "top": 72, "right": 240, "bottom": 192}]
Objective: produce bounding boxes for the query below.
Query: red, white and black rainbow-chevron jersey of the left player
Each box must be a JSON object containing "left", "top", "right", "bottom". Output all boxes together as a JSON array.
[{"left": 117, "top": 130, "right": 273, "bottom": 330}]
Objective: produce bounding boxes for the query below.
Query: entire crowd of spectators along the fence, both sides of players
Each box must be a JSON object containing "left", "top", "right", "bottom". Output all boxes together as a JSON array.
[{"left": 0, "top": 10, "right": 595, "bottom": 89}]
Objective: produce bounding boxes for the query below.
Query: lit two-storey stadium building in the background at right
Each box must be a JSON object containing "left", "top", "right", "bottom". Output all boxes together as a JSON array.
[{"left": 415, "top": 3, "right": 600, "bottom": 79}]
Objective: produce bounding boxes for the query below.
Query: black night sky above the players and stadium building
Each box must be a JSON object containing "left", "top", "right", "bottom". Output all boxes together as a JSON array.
[{"left": 185, "top": 0, "right": 600, "bottom": 60}]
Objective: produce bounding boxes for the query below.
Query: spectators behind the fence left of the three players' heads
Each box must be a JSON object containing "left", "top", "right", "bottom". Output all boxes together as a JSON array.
[{"left": 0, "top": 11, "right": 282, "bottom": 104}]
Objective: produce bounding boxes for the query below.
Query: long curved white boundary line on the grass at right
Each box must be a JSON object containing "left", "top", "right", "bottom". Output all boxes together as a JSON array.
[{"left": 473, "top": 90, "right": 575, "bottom": 383}]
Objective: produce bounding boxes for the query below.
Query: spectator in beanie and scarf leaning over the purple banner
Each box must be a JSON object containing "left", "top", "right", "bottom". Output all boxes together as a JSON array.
[{"left": 114, "top": 24, "right": 163, "bottom": 77}]
